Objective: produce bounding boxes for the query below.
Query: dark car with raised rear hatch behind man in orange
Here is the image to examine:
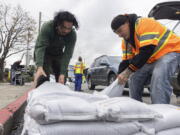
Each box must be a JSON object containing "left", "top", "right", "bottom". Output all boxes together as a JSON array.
[{"left": 148, "top": 1, "right": 180, "bottom": 96}]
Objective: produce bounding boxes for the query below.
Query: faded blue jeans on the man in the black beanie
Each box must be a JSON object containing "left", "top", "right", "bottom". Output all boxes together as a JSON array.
[{"left": 129, "top": 52, "right": 180, "bottom": 104}]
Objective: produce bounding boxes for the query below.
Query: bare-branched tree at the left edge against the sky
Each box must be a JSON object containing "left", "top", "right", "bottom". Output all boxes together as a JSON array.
[{"left": 0, "top": 3, "right": 36, "bottom": 81}]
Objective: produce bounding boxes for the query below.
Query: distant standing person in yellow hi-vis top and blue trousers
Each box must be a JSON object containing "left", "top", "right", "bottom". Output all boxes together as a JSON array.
[{"left": 74, "top": 56, "right": 85, "bottom": 91}]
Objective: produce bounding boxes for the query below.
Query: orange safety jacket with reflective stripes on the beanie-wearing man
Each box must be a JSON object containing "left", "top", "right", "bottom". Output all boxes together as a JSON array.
[{"left": 122, "top": 18, "right": 180, "bottom": 63}]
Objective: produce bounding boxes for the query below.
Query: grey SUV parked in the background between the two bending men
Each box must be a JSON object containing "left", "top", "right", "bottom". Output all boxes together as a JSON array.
[{"left": 87, "top": 55, "right": 121, "bottom": 90}]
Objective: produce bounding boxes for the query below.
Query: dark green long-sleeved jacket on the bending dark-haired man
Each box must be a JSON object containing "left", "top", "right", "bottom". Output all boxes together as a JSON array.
[{"left": 34, "top": 21, "right": 76, "bottom": 75}]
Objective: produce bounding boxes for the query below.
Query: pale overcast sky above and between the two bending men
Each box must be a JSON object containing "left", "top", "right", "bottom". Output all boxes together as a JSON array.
[{"left": 1, "top": 0, "right": 179, "bottom": 67}]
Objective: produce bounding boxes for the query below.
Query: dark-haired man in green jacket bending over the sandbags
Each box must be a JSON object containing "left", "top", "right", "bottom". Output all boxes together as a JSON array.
[{"left": 34, "top": 11, "right": 79, "bottom": 87}]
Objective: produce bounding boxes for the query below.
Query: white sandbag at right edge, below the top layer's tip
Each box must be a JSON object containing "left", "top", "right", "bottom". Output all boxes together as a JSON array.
[{"left": 143, "top": 104, "right": 180, "bottom": 132}]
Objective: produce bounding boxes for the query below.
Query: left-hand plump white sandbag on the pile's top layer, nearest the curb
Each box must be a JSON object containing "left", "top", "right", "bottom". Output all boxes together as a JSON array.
[{"left": 26, "top": 96, "right": 100, "bottom": 124}]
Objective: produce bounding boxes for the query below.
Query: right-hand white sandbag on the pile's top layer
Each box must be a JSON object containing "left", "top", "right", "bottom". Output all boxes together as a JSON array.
[{"left": 94, "top": 97, "right": 162, "bottom": 122}]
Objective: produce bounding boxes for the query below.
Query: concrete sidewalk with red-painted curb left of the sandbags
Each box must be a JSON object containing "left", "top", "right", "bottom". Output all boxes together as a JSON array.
[{"left": 0, "top": 83, "right": 32, "bottom": 135}]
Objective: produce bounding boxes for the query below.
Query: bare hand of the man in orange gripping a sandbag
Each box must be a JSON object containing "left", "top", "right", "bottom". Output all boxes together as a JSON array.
[{"left": 118, "top": 68, "right": 133, "bottom": 84}]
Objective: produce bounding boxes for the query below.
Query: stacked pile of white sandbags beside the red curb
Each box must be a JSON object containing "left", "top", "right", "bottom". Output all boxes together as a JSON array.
[{"left": 22, "top": 82, "right": 161, "bottom": 135}]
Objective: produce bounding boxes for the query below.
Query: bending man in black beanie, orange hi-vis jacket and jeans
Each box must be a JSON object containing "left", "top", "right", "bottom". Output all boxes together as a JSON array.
[{"left": 111, "top": 14, "right": 180, "bottom": 104}]
